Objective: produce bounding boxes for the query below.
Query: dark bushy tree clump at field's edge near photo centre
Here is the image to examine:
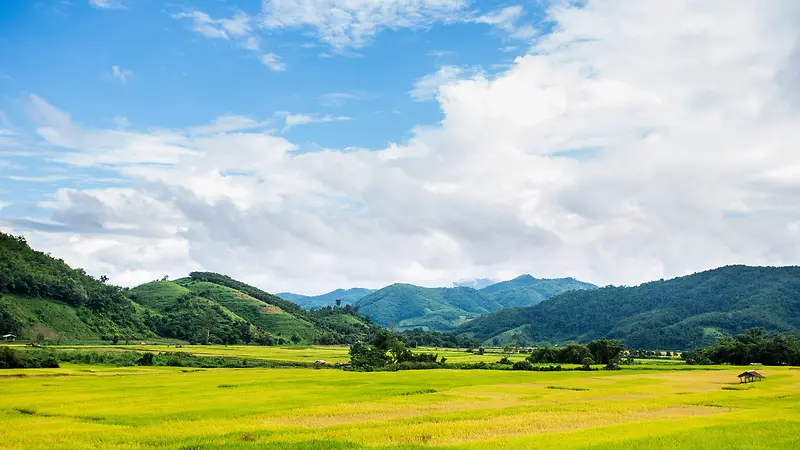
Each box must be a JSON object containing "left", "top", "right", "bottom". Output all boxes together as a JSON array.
[{"left": 350, "top": 329, "right": 446, "bottom": 372}]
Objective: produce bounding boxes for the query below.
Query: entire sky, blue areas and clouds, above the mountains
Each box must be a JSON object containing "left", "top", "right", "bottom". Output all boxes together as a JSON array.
[{"left": 0, "top": 0, "right": 800, "bottom": 294}]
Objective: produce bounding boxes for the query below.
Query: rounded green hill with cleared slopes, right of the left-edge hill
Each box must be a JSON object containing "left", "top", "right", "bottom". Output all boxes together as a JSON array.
[{"left": 130, "top": 272, "right": 375, "bottom": 345}]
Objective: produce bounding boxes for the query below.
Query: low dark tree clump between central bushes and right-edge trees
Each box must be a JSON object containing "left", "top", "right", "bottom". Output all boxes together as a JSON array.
[{"left": 526, "top": 338, "right": 625, "bottom": 366}]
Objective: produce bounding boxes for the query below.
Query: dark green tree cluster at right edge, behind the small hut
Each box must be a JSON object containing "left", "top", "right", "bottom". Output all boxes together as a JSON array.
[{"left": 681, "top": 328, "right": 800, "bottom": 366}]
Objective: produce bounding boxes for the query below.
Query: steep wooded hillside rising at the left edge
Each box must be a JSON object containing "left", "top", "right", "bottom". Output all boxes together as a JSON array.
[{"left": 0, "top": 233, "right": 154, "bottom": 339}]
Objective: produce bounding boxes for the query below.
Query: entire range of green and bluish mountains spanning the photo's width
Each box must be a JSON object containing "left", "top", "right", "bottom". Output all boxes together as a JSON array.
[{"left": 0, "top": 233, "right": 800, "bottom": 350}]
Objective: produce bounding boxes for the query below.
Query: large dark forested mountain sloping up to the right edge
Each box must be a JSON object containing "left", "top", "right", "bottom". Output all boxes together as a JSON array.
[{"left": 458, "top": 266, "right": 800, "bottom": 349}]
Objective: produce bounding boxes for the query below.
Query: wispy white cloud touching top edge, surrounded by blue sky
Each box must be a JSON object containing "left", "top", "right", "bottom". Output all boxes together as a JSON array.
[{"left": 263, "top": 0, "right": 468, "bottom": 50}]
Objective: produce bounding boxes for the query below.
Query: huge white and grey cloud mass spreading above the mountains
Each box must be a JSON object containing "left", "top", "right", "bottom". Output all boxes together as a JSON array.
[{"left": 6, "top": 0, "right": 800, "bottom": 293}]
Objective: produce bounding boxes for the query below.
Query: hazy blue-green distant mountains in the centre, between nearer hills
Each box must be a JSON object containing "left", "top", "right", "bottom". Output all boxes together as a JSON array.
[{"left": 355, "top": 275, "right": 596, "bottom": 331}]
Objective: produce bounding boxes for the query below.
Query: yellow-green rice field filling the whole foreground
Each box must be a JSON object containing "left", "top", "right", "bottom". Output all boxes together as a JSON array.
[{"left": 0, "top": 362, "right": 800, "bottom": 450}]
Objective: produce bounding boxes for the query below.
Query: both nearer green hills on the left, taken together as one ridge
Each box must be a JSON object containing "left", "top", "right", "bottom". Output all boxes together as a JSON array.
[{"left": 0, "top": 233, "right": 377, "bottom": 345}]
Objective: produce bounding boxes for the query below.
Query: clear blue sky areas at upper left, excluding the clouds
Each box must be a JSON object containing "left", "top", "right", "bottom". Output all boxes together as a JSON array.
[{"left": 0, "top": 0, "right": 542, "bottom": 220}]
